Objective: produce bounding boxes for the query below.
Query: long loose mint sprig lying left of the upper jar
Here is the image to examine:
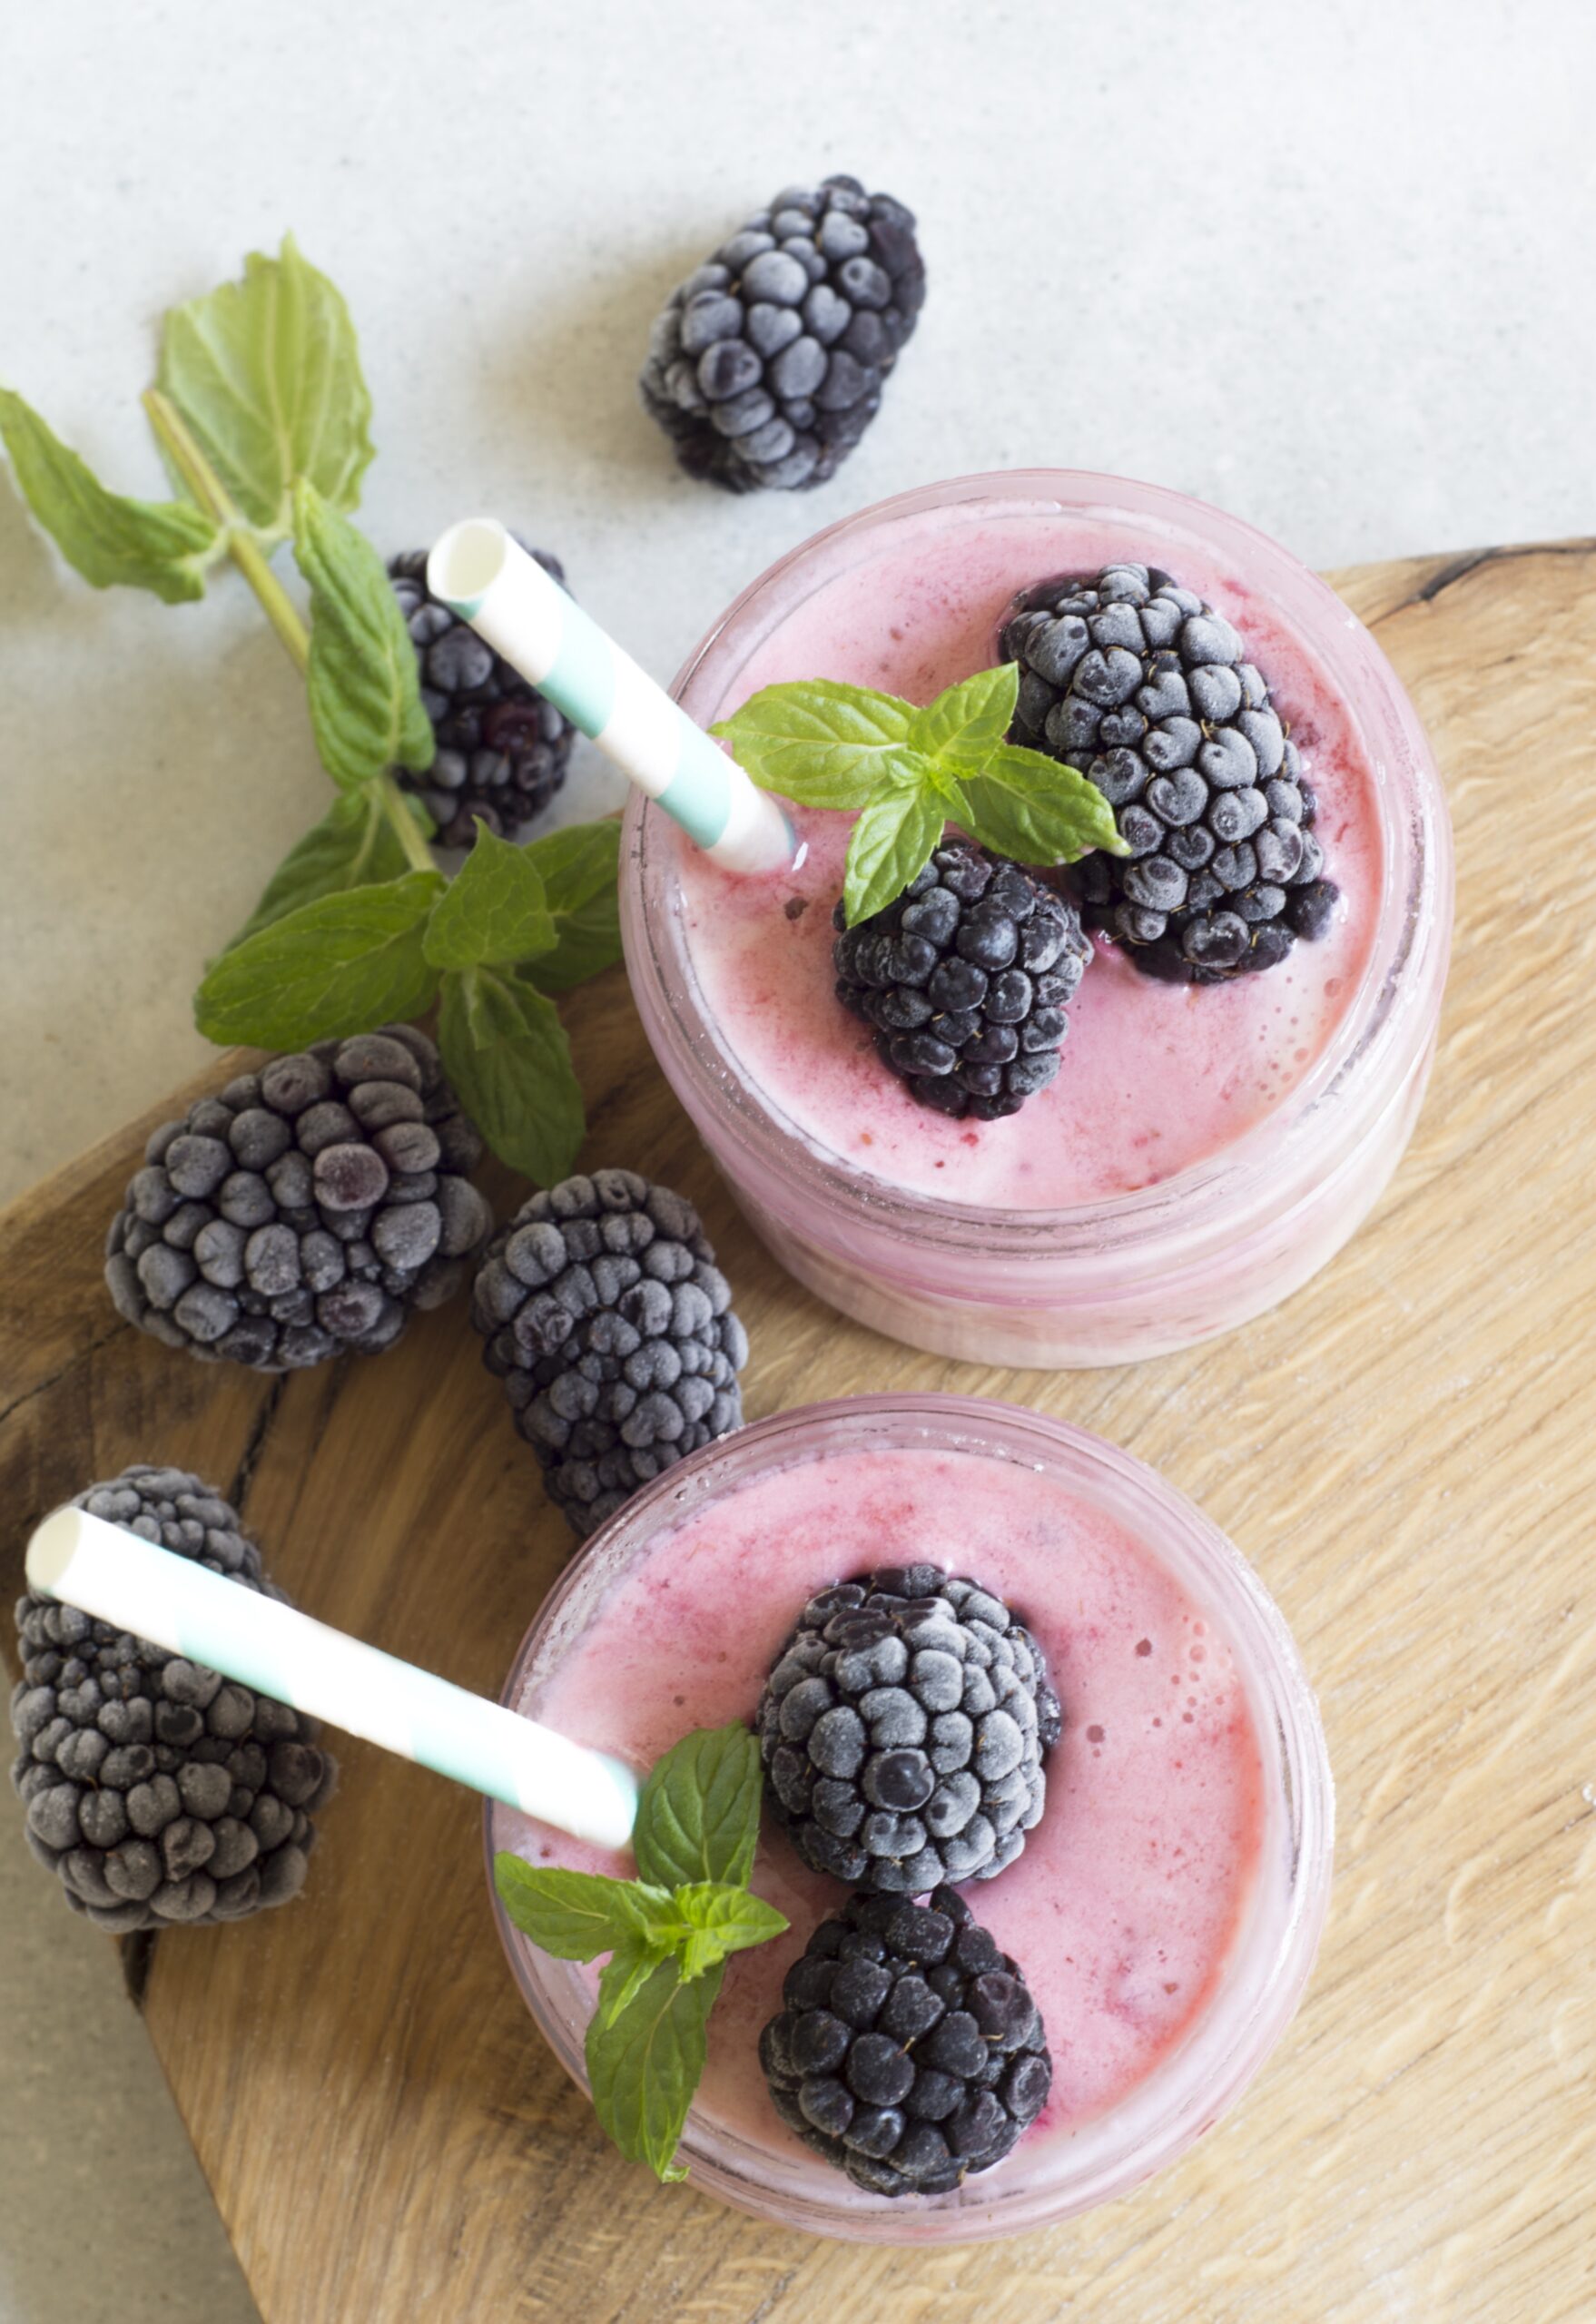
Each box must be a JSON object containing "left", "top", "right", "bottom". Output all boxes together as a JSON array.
[{"left": 0, "top": 235, "right": 620, "bottom": 1183}]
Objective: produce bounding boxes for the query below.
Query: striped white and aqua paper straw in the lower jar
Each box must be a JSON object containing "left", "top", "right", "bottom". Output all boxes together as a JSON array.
[{"left": 28, "top": 1508, "right": 639, "bottom": 1847}]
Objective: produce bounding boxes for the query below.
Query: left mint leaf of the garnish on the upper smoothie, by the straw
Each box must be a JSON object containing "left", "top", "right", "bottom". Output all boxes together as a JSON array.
[{"left": 711, "top": 679, "right": 915, "bottom": 806}]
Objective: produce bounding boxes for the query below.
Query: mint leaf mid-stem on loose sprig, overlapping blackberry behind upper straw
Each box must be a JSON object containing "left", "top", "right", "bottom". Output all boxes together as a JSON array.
[{"left": 292, "top": 477, "right": 435, "bottom": 790}]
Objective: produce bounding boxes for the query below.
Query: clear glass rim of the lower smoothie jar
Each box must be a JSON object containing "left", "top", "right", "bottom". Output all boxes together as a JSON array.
[{"left": 483, "top": 1390, "right": 1334, "bottom": 2242}]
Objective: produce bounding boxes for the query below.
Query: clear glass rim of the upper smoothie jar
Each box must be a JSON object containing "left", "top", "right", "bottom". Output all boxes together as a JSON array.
[{"left": 620, "top": 469, "right": 1452, "bottom": 1266}]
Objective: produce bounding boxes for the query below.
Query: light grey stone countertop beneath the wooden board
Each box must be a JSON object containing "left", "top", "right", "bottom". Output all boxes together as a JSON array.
[{"left": 0, "top": 0, "right": 1596, "bottom": 2324}]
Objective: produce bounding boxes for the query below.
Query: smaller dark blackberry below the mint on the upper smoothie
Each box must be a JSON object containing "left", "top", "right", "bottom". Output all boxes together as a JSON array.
[{"left": 832, "top": 839, "right": 1092, "bottom": 1122}]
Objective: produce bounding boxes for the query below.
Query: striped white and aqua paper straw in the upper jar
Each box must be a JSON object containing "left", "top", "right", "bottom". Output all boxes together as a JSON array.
[{"left": 428, "top": 516, "right": 797, "bottom": 872}]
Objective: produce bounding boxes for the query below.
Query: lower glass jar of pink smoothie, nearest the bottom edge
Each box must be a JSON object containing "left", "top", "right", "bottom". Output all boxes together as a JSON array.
[{"left": 488, "top": 1394, "right": 1334, "bottom": 2242}]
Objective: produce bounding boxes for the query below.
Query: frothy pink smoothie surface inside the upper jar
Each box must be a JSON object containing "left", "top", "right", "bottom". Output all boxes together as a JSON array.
[{"left": 676, "top": 511, "right": 1384, "bottom": 1211}]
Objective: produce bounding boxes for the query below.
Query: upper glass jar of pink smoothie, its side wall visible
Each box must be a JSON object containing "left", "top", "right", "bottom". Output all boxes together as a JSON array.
[{"left": 620, "top": 469, "right": 1452, "bottom": 1366}]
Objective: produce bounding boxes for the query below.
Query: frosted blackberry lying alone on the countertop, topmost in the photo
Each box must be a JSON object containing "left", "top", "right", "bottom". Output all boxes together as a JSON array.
[{"left": 641, "top": 177, "right": 924, "bottom": 493}]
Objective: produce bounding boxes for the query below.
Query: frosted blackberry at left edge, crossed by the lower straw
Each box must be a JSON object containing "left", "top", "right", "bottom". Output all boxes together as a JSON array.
[{"left": 12, "top": 1466, "right": 337, "bottom": 1934}]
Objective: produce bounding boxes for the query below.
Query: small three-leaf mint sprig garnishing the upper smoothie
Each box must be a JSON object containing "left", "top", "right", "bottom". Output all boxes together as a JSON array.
[{"left": 714, "top": 663, "right": 1127, "bottom": 927}]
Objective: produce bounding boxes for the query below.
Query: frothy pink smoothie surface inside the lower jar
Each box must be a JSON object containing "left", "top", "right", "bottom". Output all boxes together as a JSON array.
[{"left": 507, "top": 1450, "right": 1264, "bottom": 2168}]
